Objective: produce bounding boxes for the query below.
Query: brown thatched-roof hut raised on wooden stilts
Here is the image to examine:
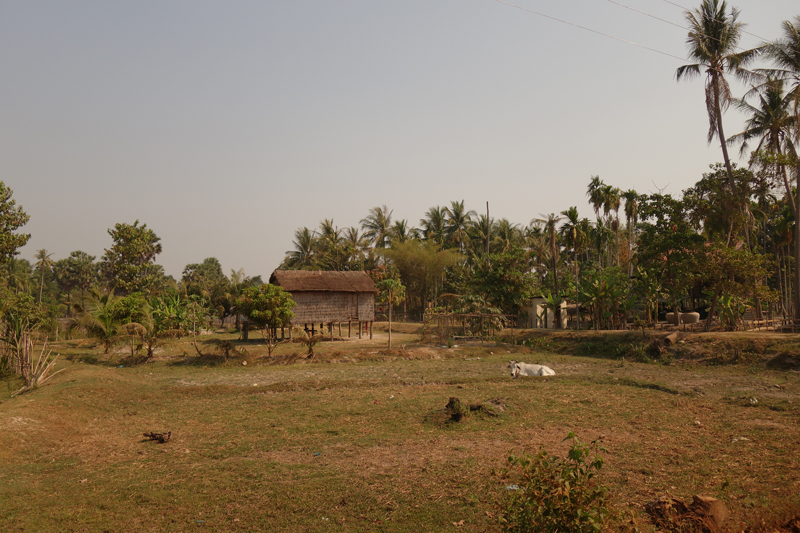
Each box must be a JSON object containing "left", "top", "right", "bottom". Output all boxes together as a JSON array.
[{"left": 269, "top": 270, "right": 377, "bottom": 338}]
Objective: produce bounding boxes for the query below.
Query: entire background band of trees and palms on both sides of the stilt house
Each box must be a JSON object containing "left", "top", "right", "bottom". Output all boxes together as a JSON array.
[{"left": 0, "top": 0, "right": 800, "bottom": 344}]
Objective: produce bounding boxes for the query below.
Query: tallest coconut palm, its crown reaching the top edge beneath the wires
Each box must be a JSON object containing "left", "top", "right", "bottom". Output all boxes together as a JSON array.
[{"left": 675, "top": 0, "right": 761, "bottom": 191}]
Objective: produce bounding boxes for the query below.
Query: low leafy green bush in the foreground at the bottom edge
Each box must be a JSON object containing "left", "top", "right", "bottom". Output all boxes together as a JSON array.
[{"left": 498, "top": 432, "right": 608, "bottom": 533}]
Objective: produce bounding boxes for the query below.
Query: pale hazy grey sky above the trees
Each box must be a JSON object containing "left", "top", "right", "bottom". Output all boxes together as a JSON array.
[{"left": 0, "top": 0, "right": 800, "bottom": 278}]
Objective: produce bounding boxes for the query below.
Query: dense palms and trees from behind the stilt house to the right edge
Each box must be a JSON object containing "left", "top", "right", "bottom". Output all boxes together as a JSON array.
[{"left": 282, "top": 0, "right": 800, "bottom": 328}]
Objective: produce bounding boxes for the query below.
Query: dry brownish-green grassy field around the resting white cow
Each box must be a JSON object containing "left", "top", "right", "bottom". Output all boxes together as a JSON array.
[{"left": 0, "top": 326, "right": 800, "bottom": 532}]
